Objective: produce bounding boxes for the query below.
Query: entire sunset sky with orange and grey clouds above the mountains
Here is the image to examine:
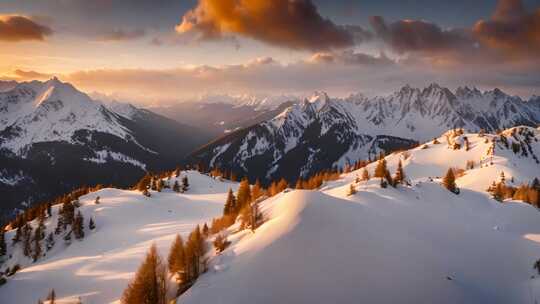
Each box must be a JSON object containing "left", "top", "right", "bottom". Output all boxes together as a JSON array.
[{"left": 0, "top": 0, "right": 540, "bottom": 104}]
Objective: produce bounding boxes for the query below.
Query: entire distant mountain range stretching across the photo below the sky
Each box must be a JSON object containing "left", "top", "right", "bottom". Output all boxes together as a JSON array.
[{"left": 0, "top": 78, "right": 540, "bottom": 216}]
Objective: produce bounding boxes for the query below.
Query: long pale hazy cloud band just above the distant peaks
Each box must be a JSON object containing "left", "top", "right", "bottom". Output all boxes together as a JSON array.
[{"left": 39, "top": 51, "right": 540, "bottom": 104}]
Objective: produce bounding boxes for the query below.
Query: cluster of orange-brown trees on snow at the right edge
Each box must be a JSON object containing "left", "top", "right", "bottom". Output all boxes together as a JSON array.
[{"left": 487, "top": 172, "right": 540, "bottom": 204}]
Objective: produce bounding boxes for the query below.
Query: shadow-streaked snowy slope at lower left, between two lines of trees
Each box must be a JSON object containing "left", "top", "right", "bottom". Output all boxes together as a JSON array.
[{"left": 0, "top": 171, "right": 237, "bottom": 304}]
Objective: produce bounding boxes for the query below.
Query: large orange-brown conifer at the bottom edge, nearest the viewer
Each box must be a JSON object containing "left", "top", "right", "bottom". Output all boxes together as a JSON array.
[{"left": 121, "top": 244, "right": 167, "bottom": 304}]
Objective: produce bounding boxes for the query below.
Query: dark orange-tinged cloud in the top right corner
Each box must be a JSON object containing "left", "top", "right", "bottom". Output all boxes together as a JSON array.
[{"left": 472, "top": 0, "right": 540, "bottom": 59}]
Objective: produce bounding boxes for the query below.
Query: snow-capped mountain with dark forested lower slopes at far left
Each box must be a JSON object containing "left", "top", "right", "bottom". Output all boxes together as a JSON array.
[{"left": 0, "top": 78, "right": 210, "bottom": 220}]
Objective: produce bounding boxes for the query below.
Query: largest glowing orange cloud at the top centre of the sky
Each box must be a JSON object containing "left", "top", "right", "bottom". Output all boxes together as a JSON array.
[{"left": 176, "top": 0, "right": 362, "bottom": 51}]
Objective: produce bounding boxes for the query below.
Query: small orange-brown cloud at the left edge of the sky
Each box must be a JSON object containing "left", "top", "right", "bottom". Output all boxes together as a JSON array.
[{"left": 0, "top": 15, "right": 53, "bottom": 42}]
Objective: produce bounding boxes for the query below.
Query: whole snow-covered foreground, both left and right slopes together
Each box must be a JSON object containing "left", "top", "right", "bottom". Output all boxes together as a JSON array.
[{"left": 0, "top": 127, "right": 540, "bottom": 304}]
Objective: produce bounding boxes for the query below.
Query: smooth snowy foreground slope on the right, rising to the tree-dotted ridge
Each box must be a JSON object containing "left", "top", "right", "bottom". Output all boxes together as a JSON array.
[{"left": 177, "top": 128, "right": 540, "bottom": 304}]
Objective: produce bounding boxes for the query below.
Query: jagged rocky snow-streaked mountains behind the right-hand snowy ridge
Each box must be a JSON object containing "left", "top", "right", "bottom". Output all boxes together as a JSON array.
[{"left": 192, "top": 84, "right": 540, "bottom": 180}]
